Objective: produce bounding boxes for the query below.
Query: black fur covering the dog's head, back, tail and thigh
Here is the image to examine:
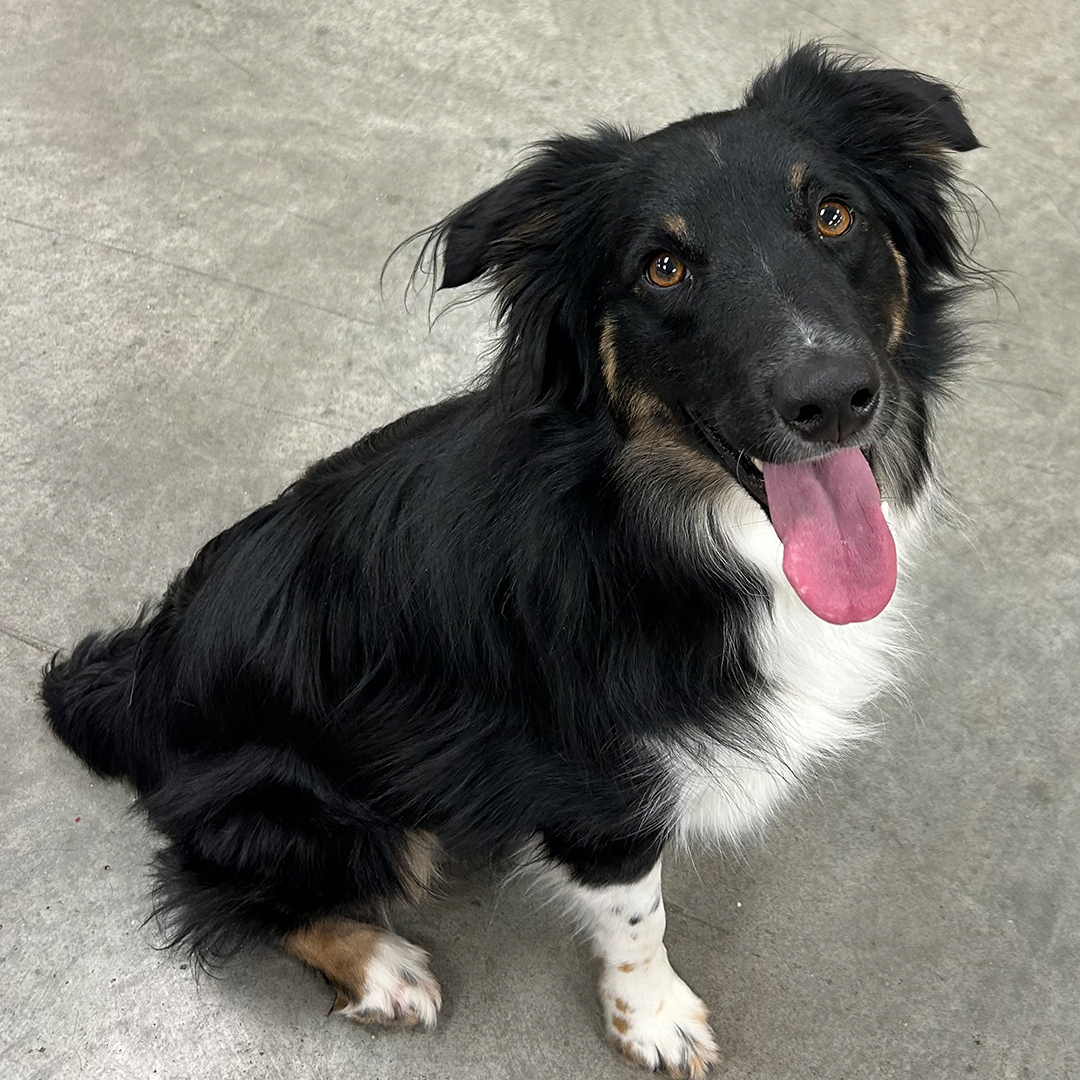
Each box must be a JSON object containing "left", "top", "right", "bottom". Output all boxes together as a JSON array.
[{"left": 42, "top": 45, "right": 977, "bottom": 956}]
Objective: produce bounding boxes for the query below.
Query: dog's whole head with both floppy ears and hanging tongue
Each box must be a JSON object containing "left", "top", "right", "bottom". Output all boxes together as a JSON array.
[{"left": 423, "top": 44, "right": 978, "bottom": 622}]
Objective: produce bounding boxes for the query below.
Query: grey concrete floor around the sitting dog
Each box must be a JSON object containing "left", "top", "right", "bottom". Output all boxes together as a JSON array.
[{"left": 0, "top": 0, "right": 1080, "bottom": 1080}]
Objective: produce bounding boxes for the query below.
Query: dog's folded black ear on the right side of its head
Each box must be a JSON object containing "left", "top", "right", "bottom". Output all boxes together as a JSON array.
[{"left": 746, "top": 42, "right": 980, "bottom": 281}]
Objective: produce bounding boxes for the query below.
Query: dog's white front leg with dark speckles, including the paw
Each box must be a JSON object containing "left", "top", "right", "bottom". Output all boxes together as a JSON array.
[{"left": 550, "top": 853, "right": 719, "bottom": 1080}]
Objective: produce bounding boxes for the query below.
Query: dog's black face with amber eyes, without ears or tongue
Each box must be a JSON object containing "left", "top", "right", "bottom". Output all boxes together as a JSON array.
[{"left": 599, "top": 111, "right": 908, "bottom": 481}]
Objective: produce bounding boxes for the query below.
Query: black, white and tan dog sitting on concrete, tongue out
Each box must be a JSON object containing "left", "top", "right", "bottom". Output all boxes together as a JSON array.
[{"left": 41, "top": 43, "right": 980, "bottom": 1078}]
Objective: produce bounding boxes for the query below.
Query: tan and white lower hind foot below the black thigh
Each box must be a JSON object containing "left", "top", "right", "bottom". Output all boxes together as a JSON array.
[{"left": 284, "top": 918, "right": 443, "bottom": 1029}]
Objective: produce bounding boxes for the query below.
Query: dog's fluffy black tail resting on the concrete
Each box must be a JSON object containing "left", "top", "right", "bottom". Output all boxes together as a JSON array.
[{"left": 41, "top": 608, "right": 159, "bottom": 787}]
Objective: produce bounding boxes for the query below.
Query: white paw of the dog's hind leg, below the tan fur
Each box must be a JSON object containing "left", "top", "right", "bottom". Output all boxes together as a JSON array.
[{"left": 330, "top": 933, "right": 443, "bottom": 1030}]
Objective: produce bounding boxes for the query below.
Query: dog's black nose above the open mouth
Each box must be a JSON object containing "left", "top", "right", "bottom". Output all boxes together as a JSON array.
[{"left": 772, "top": 352, "right": 881, "bottom": 443}]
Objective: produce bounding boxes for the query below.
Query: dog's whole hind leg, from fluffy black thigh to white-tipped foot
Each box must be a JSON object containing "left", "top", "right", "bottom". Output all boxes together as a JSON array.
[{"left": 143, "top": 746, "right": 442, "bottom": 1028}]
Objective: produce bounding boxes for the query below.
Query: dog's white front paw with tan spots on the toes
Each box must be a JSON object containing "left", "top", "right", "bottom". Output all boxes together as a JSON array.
[{"left": 603, "top": 972, "right": 720, "bottom": 1080}]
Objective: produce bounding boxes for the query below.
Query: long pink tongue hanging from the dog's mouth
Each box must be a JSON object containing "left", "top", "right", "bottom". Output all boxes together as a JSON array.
[{"left": 765, "top": 449, "right": 896, "bottom": 623}]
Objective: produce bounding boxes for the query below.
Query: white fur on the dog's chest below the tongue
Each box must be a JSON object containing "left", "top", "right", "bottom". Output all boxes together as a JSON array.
[{"left": 671, "top": 492, "right": 921, "bottom": 843}]
